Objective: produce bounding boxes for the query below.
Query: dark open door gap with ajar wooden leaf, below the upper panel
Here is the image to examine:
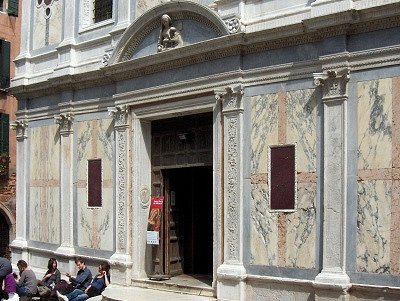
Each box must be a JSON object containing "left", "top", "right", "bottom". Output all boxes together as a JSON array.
[{"left": 161, "top": 167, "right": 213, "bottom": 276}]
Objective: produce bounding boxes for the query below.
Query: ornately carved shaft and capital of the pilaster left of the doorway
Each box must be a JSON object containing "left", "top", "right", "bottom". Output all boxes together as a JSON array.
[{"left": 108, "top": 105, "right": 128, "bottom": 253}]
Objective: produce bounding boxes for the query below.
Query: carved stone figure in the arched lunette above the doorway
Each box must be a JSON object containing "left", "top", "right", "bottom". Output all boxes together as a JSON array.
[{"left": 157, "top": 14, "right": 183, "bottom": 52}]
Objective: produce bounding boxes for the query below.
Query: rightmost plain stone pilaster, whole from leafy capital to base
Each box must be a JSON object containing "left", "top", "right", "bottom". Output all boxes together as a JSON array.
[{"left": 314, "top": 69, "right": 350, "bottom": 300}]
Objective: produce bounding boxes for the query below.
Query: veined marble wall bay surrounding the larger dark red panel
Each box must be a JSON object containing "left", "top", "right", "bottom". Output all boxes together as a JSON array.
[{"left": 250, "top": 89, "right": 317, "bottom": 268}]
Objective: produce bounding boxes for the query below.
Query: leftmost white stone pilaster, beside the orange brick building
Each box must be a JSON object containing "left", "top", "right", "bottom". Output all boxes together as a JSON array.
[{"left": 11, "top": 120, "right": 29, "bottom": 250}]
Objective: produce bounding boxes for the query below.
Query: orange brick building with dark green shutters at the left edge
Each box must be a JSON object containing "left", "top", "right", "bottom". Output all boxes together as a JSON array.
[{"left": 0, "top": 0, "right": 21, "bottom": 257}]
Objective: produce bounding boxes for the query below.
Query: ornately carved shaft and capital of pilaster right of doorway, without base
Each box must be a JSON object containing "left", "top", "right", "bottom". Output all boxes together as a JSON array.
[{"left": 216, "top": 86, "right": 243, "bottom": 262}]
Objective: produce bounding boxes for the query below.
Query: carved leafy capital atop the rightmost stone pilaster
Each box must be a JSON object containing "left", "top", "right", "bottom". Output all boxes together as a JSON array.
[{"left": 314, "top": 69, "right": 350, "bottom": 101}]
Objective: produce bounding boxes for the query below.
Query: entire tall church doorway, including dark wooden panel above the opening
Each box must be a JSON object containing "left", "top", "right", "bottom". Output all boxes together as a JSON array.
[{"left": 149, "top": 112, "right": 213, "bottom": 278}]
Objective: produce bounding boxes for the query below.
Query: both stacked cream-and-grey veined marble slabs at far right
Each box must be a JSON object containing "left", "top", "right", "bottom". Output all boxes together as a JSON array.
[{"left": 357, "top": 78, "right": 392, "bottom": 273}]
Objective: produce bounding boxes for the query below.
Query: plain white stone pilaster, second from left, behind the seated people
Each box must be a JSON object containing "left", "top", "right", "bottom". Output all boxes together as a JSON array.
[{"left": 54, "top": 113, "right": 75, "bottom": 255}]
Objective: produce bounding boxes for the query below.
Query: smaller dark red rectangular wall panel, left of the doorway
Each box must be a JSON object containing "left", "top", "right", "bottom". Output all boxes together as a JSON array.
[{"left": 88, "top": 159, "right": 102, "bottom": 207}]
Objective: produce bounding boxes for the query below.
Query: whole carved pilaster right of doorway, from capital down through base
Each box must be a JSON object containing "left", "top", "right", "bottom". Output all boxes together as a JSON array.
[{"left": 215, "top": 86, "right": 246, "bottom": 300}]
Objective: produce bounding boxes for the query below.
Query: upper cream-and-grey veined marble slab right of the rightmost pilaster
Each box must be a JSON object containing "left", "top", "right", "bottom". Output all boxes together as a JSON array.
[{"left": 357, "top": 78, "right": 392, "bottom": 169}]
